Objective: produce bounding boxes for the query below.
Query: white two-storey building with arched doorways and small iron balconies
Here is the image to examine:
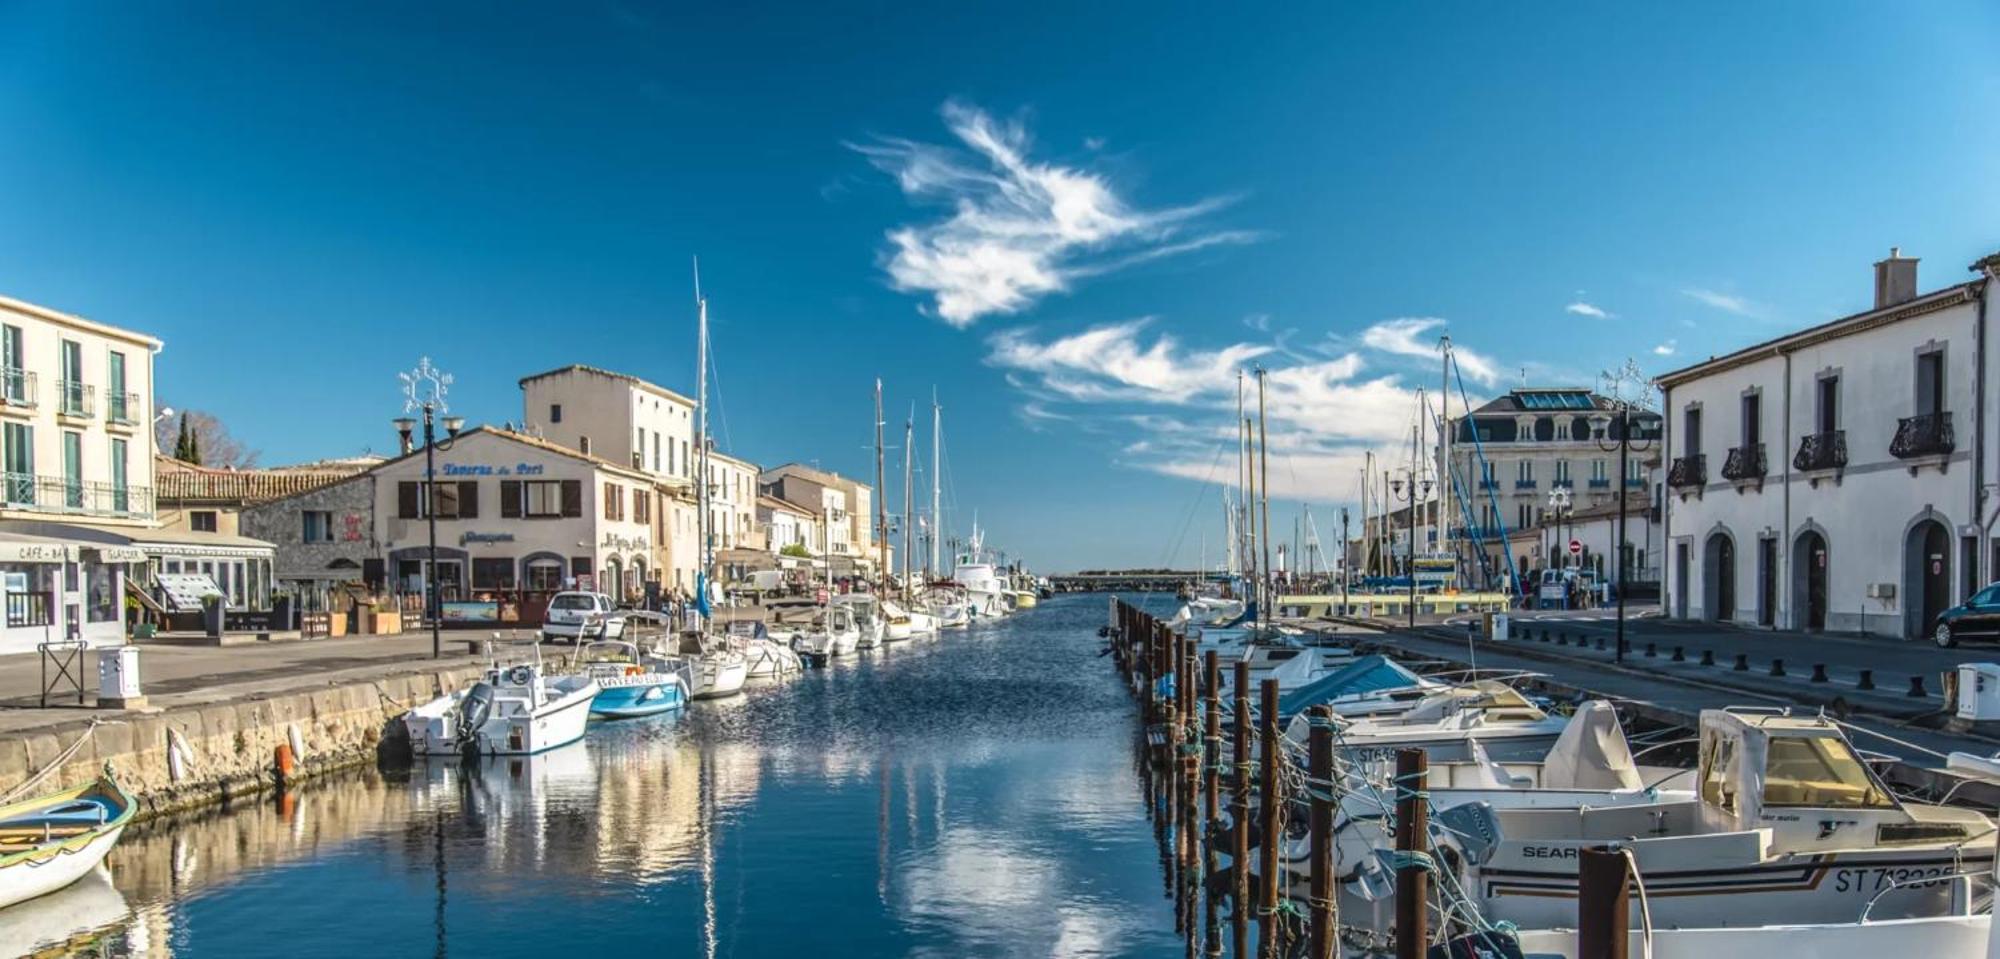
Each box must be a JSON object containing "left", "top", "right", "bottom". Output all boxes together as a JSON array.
[{"left": 1658, "top": 250, "right": 2000, "bottom": 637}]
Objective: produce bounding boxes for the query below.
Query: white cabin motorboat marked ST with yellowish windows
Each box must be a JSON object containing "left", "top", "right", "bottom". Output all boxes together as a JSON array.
[{"left": 1376, "top": 709, "right": 1994, "bottom": 935}]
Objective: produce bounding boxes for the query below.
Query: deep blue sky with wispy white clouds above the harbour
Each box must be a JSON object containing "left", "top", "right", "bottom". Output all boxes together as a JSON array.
[{"left": 0, "top": 0, "right": 2000, "bottom": 569}]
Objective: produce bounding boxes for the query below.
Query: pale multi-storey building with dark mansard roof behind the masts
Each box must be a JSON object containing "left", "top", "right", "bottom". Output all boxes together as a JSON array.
[{"left": 1448, "top": 388, "right": 1660, "bottom": 585}]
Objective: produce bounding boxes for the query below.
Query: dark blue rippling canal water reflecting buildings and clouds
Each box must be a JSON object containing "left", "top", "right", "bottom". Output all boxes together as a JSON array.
[{"left": 15, "top": 595, "right": 1180, "bottom": 959}]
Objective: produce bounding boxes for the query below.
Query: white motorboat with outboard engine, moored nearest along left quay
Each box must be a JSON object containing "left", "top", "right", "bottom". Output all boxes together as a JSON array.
[{"left": 402, "top": 647, "right": 598, "bottom": 755}]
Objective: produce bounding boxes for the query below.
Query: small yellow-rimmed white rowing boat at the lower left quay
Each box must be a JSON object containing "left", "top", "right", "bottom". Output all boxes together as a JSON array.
[{"left": 0, "top": 771, "right": 134, "bottom": 909}]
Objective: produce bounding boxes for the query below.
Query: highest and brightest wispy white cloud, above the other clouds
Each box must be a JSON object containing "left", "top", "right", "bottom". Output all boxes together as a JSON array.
[{"left": 850, "top": 102, "right": 1256, "bottom": 328}]
